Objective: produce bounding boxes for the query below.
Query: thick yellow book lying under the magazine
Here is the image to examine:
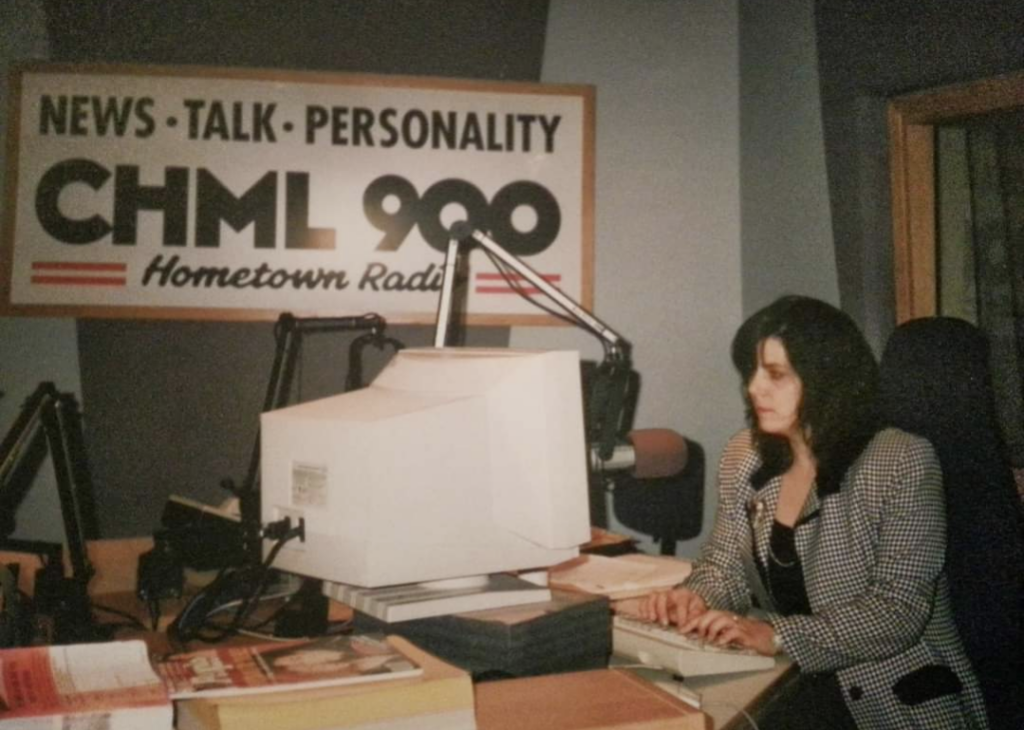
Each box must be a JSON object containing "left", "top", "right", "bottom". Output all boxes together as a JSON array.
[{"left": 175, "top": 637, "right": 476, "bottom": 730}]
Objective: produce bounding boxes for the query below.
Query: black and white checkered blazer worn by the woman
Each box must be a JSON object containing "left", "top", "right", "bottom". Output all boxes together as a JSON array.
[{"left": 684, "top": 429, "right": 987, "bottom": 730}]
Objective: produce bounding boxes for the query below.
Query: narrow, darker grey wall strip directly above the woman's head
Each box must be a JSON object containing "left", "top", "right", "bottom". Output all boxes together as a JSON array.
[{"left": 739, "top": 0, "right": 840, "bottom": 314}]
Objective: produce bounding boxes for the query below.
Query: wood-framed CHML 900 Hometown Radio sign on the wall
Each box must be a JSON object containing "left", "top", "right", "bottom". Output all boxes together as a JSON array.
[{"left": 0, "top": 65, "right": 594, "bottom": 324}]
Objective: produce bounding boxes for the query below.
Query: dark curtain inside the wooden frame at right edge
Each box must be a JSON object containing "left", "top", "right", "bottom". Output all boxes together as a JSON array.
[{"left": 967, "top": 114, "right": 1024, "bottom": 469}]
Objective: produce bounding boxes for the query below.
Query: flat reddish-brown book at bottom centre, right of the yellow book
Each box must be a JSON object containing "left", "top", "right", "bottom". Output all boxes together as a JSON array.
[{"left": 475, "top": 669, "right": 712, "bottom": 730}]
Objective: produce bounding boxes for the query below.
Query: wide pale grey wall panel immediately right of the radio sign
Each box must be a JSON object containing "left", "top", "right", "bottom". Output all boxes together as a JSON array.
[{"left": 520, "top": 0, "right": 742, "bottom": 554}]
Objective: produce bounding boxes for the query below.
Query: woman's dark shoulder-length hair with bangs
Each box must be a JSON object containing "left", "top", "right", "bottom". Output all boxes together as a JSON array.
[{"left": 732, "top": 296, "right": 880, "bottom": 497}]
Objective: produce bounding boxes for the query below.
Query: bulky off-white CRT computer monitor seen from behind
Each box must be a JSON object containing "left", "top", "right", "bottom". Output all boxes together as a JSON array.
[{"left": 260, "top": 348, "right": 590, "bottom": 587}]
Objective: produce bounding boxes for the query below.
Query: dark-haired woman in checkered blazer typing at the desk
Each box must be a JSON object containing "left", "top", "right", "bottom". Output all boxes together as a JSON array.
[{"left": 640, "top": 297, "right": 987, "bottom": 730}]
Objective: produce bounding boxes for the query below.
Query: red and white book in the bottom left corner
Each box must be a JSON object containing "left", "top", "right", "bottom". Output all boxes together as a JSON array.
[{"left": 0, "top": 641, "right": 173, "bottom": 730}]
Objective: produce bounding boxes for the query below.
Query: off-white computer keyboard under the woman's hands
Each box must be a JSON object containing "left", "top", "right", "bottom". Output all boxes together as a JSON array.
[{"left": 611, "top": 614, "right": 775, "bottom": 678}]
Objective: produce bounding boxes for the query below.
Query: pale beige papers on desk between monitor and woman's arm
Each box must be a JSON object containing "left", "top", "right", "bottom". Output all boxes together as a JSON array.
[{"left": 550, "top": 553, "right": 692, "bottom": 601}]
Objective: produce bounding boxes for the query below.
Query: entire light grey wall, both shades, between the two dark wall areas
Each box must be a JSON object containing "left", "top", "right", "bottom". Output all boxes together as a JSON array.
[{"left": 520, "top": 0, "right": 839, "bottom": 556}]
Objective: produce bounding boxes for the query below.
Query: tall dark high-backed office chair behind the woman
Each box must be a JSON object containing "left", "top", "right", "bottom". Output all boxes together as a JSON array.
[{"left": 881, "top": 317, "right": 1024, "bottom": 730}]
